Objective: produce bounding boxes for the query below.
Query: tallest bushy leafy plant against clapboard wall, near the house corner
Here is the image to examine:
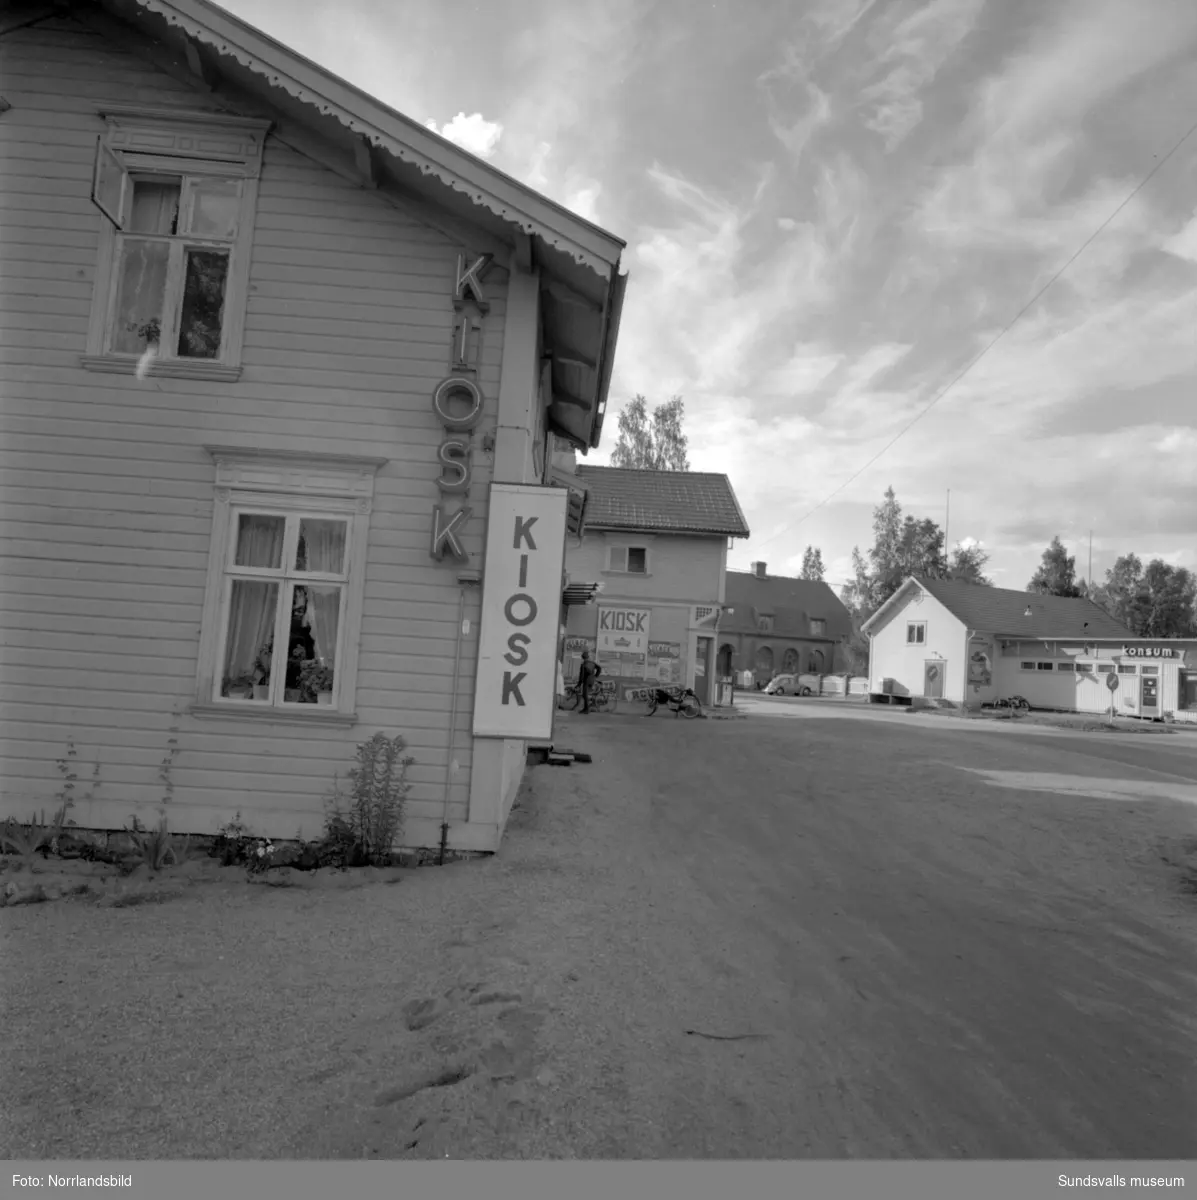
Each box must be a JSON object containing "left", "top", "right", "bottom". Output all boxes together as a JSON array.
[{"left": 325, "top": 733, "right": 415, "bottom": 866}]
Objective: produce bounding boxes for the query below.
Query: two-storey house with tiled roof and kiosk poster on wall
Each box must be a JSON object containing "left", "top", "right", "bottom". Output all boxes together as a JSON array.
[{"left": 554, "top": 463, "right": 748, "bottom": 704}]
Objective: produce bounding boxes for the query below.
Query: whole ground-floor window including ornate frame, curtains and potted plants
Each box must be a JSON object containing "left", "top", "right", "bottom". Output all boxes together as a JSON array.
[{"left": 197, "top": 450, "right": 379, "bottom": 716}]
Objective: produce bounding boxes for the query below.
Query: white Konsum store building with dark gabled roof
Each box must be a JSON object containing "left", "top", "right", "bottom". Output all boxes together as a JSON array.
[{"left": 861, "top": 577, "right": 1197, "bottom": 721}]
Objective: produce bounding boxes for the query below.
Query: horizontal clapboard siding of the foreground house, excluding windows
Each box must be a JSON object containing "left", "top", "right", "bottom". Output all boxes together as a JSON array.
[{"left": 0, "top": 19, "right": 505, "bottom": 836}]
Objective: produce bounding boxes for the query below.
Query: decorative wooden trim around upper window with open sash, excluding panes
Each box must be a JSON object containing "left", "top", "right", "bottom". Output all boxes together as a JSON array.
[{"left": 80, "top": 111, "right": 271, "bottom": 382}]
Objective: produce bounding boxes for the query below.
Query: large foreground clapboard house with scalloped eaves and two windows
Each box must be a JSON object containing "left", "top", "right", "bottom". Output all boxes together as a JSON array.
[{"left": 0, "top": 0, "right": 625, "bottom": 850}]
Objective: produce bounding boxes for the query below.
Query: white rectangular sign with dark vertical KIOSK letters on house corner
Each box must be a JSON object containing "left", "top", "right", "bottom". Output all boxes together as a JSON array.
[{"left": 474, "top": 484, "right": 569, "bottom": 738}]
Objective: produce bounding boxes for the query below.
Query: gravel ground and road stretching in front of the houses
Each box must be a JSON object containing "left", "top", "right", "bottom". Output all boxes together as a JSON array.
[{"left": 0, "top": 714, "right": 1197, "bottom": 1160}]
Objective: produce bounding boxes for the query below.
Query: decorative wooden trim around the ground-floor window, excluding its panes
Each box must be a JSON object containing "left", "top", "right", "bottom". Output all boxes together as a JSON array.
[{"left": 191, "top": 446, "right": 387, "bottom": 725}]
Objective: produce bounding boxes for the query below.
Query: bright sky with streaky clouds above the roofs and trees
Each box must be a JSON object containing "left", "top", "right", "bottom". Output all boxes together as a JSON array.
[{"left": 224, "top": 0, "right": 1197, "bottom": 588}]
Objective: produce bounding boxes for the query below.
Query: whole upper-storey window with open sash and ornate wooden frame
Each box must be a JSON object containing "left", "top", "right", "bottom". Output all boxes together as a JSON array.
[{"left": 84, "top": 109, "right": 266, "bottom": 378}]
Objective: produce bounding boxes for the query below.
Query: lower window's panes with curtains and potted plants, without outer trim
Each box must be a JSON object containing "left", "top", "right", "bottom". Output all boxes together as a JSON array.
[{"left": 216, "top": 510, "right": 353, "bottom": 707}]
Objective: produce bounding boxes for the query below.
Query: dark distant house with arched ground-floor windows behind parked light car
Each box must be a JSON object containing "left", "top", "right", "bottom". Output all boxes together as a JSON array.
[{"left": 718, "top": 563, "right": 852, "bottom": 685}]
